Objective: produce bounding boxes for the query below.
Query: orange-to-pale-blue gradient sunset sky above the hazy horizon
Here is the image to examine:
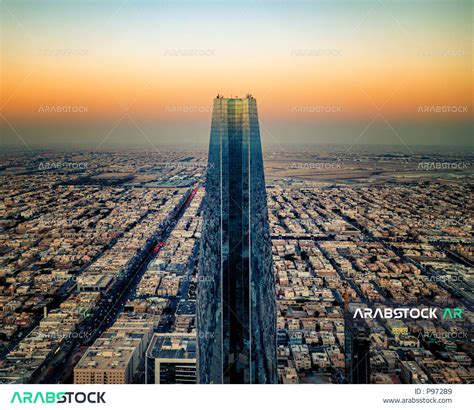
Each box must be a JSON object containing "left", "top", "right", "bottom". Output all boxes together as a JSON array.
[{"left": 0, "top": 0, "right": 473, "bottom": 147}]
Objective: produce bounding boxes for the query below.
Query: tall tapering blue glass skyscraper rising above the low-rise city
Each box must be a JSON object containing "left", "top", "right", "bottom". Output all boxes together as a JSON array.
[{"left": 197, "top": 95, "right": 277, "bottom": 383}]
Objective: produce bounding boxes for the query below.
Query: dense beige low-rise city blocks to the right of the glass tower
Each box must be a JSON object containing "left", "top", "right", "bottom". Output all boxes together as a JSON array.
[{"left": 267, "top": 149, "right": 473, "bottom": 383}]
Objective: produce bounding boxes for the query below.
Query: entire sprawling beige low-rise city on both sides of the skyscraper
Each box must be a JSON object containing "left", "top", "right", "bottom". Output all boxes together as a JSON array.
[{"left": 0, "top": 147, "right": 474, "bottom": 384}]
